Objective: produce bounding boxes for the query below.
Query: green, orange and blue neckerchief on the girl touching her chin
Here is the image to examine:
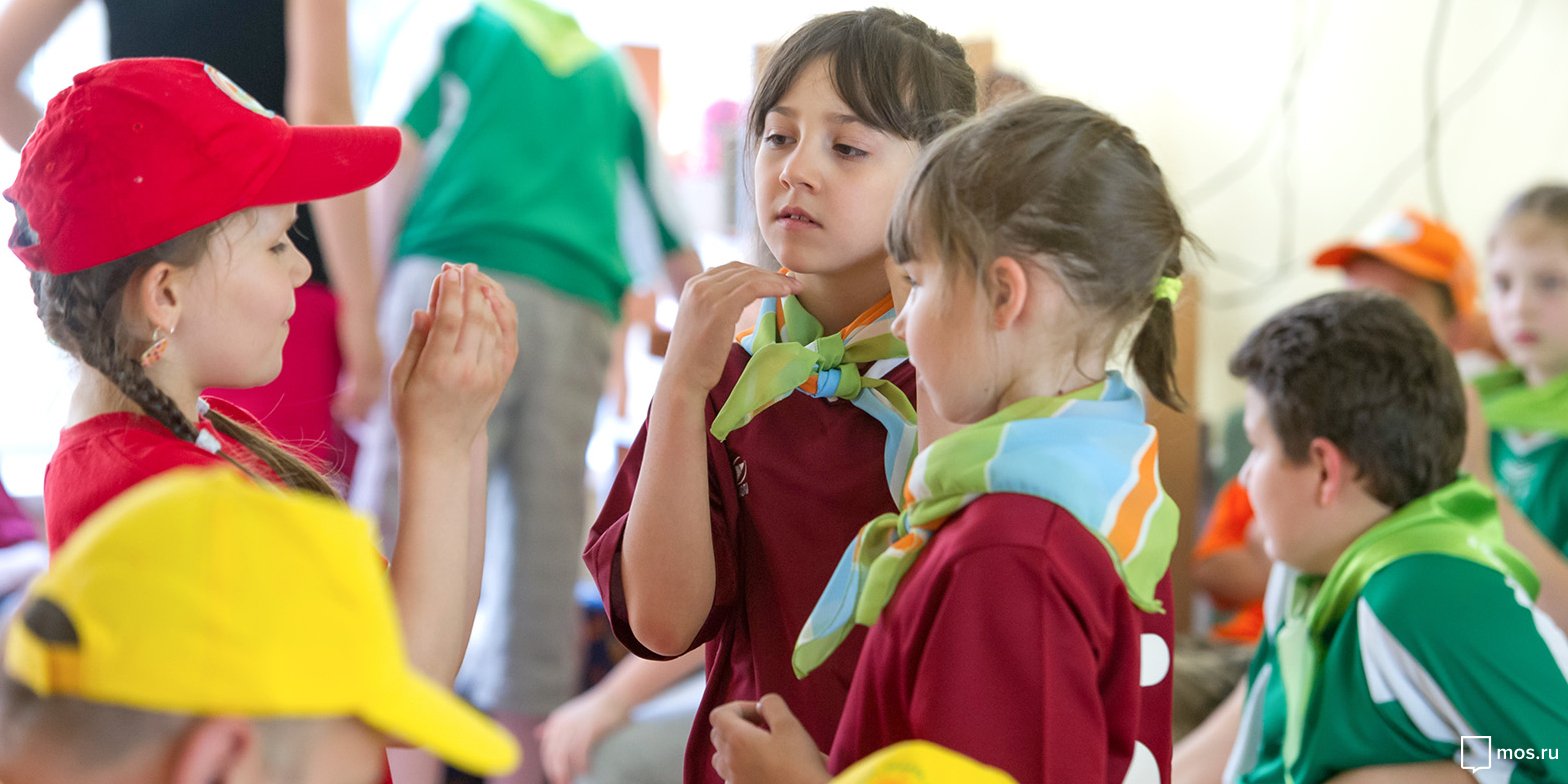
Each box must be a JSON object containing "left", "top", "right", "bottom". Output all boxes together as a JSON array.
[{"left": 710, "top": 295, "right": 917, "bottom": 502}]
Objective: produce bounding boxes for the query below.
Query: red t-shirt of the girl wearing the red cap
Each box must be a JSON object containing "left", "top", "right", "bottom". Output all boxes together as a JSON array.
[{"left": 44, "top": 398, "right": 279, "bottom": 554}]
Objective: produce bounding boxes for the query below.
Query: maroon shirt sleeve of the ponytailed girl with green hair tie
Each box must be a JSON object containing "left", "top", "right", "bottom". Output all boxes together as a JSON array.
[{"left": 911, "top": 547, "right": 1137, "bottom": 782}]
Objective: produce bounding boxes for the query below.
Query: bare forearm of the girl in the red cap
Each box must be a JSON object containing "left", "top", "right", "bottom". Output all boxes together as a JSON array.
[{"left": 390, "top": 447, "right": 483, "bottom": 684}]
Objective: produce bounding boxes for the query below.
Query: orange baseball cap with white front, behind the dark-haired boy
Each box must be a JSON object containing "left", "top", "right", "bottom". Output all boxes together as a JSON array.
[{"left": 1312, "top": 209, "right": 1475, "bottom": 317}]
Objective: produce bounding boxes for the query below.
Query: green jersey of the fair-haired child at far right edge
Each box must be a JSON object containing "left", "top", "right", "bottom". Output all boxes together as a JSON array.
[{"left": 1491, "top": 430, "right": 1568, "bottom": 554}]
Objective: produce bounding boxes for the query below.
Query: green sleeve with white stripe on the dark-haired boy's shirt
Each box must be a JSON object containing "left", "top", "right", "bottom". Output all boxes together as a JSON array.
[{"left": 1355, "top": 555, "right": 1568, "bottom": 784}]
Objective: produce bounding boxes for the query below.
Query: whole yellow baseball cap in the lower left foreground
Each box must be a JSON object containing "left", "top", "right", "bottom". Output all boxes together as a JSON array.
[{"left": 5, "top": 467, "right": 519, "bottom": 776}]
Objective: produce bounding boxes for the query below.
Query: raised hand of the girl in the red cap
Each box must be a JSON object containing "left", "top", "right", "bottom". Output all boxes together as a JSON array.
[{"left": 392, "top": 263, "right": 517, "bottom": 458}]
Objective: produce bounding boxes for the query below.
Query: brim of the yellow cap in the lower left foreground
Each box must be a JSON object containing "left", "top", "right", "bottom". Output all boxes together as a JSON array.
[{"left": 359, "top": 671, "right": 521, "bottom": 776}]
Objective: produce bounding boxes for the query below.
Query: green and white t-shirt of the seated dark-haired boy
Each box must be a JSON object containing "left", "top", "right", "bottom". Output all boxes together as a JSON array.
[{"left": 1225, "top": 554, "right": 1568, "bottom": 784}]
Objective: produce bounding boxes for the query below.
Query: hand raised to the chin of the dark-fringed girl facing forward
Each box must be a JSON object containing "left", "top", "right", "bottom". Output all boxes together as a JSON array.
[{"left": 660, "top": 262, "right": 800, "bottom": 397}]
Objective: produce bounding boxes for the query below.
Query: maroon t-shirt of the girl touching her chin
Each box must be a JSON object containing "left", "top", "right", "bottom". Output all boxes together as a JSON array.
[{"left": 583, "top": 345, "right": 914, "bottom": 782}]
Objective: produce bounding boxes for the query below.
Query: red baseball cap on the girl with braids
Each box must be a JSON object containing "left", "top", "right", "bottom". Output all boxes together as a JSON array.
[{"left": 5, "top": 58, "right": 400, "bottom": 274}]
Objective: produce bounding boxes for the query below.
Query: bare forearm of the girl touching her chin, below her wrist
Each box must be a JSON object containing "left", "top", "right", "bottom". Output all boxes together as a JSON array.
[{"left": 621, "top": 373, "right": 715, "bottom": 655}]
